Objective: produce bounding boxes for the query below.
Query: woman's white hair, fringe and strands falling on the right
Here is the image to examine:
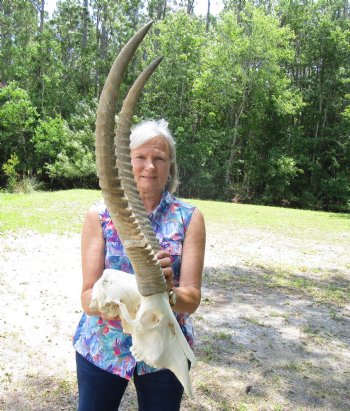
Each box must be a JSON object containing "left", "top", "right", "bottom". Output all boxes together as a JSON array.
[{"left": 130, "top": 119, "right": 179, "bottom": 193}]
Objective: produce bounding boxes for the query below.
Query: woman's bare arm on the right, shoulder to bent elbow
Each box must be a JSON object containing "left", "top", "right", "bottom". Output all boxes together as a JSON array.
[{"left": 172, "top": 208, "right": 205, "bottom": 314}]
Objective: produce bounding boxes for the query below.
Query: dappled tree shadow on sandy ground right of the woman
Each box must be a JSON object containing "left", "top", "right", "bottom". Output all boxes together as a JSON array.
[{"left": 189, "top": 266, "right": 350, "bottom": 410}]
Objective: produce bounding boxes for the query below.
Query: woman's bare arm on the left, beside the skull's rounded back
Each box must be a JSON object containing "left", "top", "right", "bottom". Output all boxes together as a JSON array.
[{"left": 81, "top": 208, "right": 105, "bottom": 316}]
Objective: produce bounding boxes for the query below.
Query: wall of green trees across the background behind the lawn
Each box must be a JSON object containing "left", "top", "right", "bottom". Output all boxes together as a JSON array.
[{"left": 0, "top": 0, "right": 350, "bottom": 211}]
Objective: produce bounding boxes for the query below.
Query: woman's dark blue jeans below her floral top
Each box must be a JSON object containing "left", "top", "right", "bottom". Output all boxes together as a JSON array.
[{"left": 76, "top": 353, "right": 184, "bottom": 411}]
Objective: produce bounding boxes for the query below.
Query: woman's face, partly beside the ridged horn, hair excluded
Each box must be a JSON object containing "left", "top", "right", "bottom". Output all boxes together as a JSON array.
[{"left": 131, "top": 136, "right": 171, "bottom": 195}]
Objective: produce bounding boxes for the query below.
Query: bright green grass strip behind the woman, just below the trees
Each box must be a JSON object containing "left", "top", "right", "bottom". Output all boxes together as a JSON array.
[{"left": 0, "top": 190, "right": 350, "bottom": 241}]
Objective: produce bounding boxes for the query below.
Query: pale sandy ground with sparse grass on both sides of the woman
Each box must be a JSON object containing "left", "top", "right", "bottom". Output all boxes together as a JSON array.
[{"left": 0, "top": 226, "right": 350, "bottom": 411}]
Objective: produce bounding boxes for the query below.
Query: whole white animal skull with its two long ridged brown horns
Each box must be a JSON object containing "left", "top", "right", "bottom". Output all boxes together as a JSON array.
[{"left": 90, "top": 23, "right": 195, "bottom": 398}]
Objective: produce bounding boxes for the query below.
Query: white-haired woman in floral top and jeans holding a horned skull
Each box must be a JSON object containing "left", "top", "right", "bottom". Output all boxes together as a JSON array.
[{"left": 74, "top": 120, "right": 205, "bottom": 411}]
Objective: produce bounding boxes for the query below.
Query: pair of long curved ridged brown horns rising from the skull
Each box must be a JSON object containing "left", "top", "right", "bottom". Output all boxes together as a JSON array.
[{"left": 96, "top": 23, "right": 166, "bottom": 296}]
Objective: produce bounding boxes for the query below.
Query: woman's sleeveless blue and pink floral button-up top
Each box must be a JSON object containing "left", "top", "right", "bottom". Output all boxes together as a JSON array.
[{"left": 73, "top": 191, "right": 194, "bottom": 380}]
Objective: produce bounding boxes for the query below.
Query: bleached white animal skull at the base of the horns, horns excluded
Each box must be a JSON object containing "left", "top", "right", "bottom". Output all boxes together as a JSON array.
[{"left": 90, "top": 269, "right": 195, "bottom": 398}]
